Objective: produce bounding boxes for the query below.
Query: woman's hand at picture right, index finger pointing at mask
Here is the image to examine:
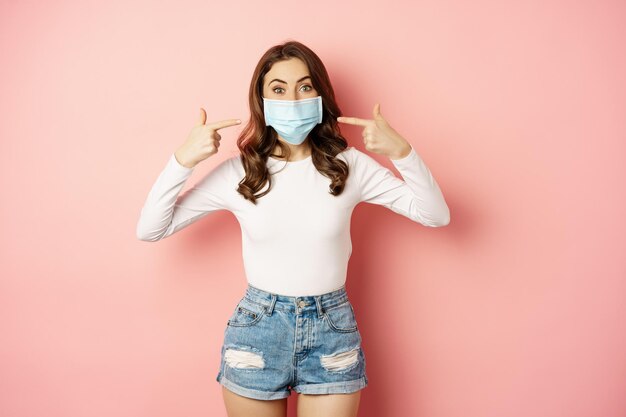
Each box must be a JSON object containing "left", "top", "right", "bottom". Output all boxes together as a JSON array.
[{"left": 337, "top": 104, "right": 411, "bottom": 159}]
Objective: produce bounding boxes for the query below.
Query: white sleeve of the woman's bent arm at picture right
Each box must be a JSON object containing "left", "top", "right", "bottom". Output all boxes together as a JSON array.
[{"left": 353, "top": 146, "right": 450, "bottom": 227}]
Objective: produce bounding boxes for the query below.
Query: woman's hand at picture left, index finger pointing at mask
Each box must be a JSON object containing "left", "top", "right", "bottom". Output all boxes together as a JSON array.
[{"left": 175, "top": 107, "right": 241, "bottom": 168}]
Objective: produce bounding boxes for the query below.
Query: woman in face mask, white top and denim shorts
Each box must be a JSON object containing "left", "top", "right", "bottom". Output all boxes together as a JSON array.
[{"left": 137, "top": 41, "right": 450, "bottom": 417}]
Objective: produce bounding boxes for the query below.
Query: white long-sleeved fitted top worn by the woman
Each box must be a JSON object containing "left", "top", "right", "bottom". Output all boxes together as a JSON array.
[{"left": 137, "top": 147, "right": 450, "bottom": 296}]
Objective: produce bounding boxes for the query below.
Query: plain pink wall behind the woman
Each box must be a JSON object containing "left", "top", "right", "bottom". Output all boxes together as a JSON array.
[{"left": 0, "top": 0, "right": 626, "bottom": 417}]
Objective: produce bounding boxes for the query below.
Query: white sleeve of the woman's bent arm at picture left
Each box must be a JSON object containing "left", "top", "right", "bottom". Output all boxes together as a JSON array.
[{"left": 136, "top": 154, "right": 236, "bottom": 242}]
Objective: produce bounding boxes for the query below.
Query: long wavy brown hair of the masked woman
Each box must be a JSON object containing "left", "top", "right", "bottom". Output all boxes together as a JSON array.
[{"left": 237, "top": 40, "right": 349, "bottom": 204}]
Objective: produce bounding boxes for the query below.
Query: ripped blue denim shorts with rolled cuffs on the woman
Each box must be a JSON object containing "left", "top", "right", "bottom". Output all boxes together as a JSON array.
[{"left": 216, "top": 285, "right": 367, "bottom": 400}]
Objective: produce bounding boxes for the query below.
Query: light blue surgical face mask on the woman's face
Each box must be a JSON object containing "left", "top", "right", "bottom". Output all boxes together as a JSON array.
[{"left": 263, "top": 96, "right": 322, "bottom": 145}]
